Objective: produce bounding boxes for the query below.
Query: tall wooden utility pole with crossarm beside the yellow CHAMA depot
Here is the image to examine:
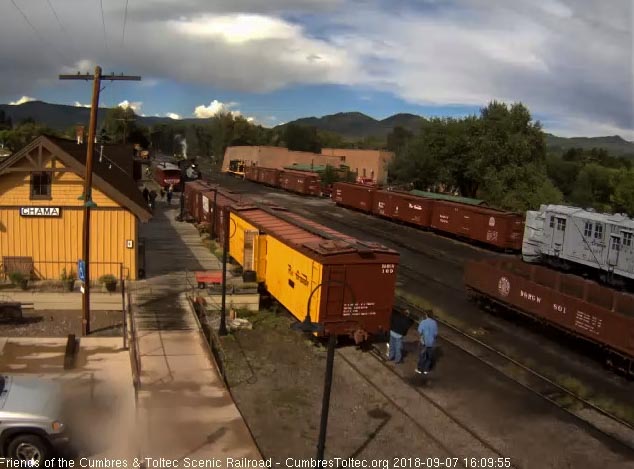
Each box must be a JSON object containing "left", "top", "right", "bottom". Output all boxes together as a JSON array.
[{"left": 59, "top": 65, "right": 141, "bottom": 336}]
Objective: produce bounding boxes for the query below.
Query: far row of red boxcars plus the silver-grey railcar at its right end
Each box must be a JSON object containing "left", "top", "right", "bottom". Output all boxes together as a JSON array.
[{"left": 233, "top": 166, "right": 634, "bottom": 290}]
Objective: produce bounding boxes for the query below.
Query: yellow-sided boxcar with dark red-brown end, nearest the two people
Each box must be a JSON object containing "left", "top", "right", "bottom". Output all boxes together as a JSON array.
[{"left": 231, "top": 207, "right": 399, "bottom": 338}]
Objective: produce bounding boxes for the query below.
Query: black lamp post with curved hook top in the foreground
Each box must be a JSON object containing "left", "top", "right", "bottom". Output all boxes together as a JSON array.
[{"left": 291, "top": 280, "right": 356, "bottom": 461}]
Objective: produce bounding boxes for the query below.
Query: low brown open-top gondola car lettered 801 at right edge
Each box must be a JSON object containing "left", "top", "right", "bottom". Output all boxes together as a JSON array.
[{"left": 465, "top": 258, "right": 634, "bottom": 374}]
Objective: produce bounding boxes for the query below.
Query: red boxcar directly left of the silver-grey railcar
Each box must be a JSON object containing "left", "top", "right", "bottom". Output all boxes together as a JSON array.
[{"left": 431, "top": 200, "right": 524, "bottom": 251}]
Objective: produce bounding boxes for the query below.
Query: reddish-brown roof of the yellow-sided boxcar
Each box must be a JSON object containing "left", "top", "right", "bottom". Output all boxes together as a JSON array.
[{"left": 234, "top": 207, "right": 397, "bottom": 256}]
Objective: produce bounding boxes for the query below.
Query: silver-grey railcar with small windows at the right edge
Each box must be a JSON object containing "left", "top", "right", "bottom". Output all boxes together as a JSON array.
[{"left": 522, "top": 205, "right": 634, "bottom": 287}]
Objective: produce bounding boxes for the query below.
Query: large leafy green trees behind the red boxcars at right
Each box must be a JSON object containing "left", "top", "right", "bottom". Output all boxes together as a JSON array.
[{"left": 387, "top": 101, "right": 634, "bottom": 215}]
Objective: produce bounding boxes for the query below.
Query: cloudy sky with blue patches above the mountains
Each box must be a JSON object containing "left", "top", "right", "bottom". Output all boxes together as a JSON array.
[{"left": 0, "top": 0, "right": 634, "bottom": 140}]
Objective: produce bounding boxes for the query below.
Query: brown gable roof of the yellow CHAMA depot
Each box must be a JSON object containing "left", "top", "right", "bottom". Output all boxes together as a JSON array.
[{"left": 0, "top": 135, "right": 152, "bottom": 222}]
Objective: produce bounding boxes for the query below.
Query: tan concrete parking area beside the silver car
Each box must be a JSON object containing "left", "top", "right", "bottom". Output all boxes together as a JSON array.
[{"left": 0, "top": 337, "right": 137, "bottom": 460}]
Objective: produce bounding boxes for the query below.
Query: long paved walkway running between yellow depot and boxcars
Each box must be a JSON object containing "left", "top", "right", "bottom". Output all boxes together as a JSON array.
[{"left": 132, "top": 199, "right": 261, "bottom": 460}]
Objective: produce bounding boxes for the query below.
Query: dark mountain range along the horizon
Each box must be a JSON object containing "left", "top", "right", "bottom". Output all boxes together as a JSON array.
[{"left": 0, "top": 101, "right": 634, "bottom": 156}]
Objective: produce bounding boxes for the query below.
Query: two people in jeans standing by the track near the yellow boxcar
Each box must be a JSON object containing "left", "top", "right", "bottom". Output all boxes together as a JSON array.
[{"left": 387, "top": 310, "right": 438, "bottom": 375}]
